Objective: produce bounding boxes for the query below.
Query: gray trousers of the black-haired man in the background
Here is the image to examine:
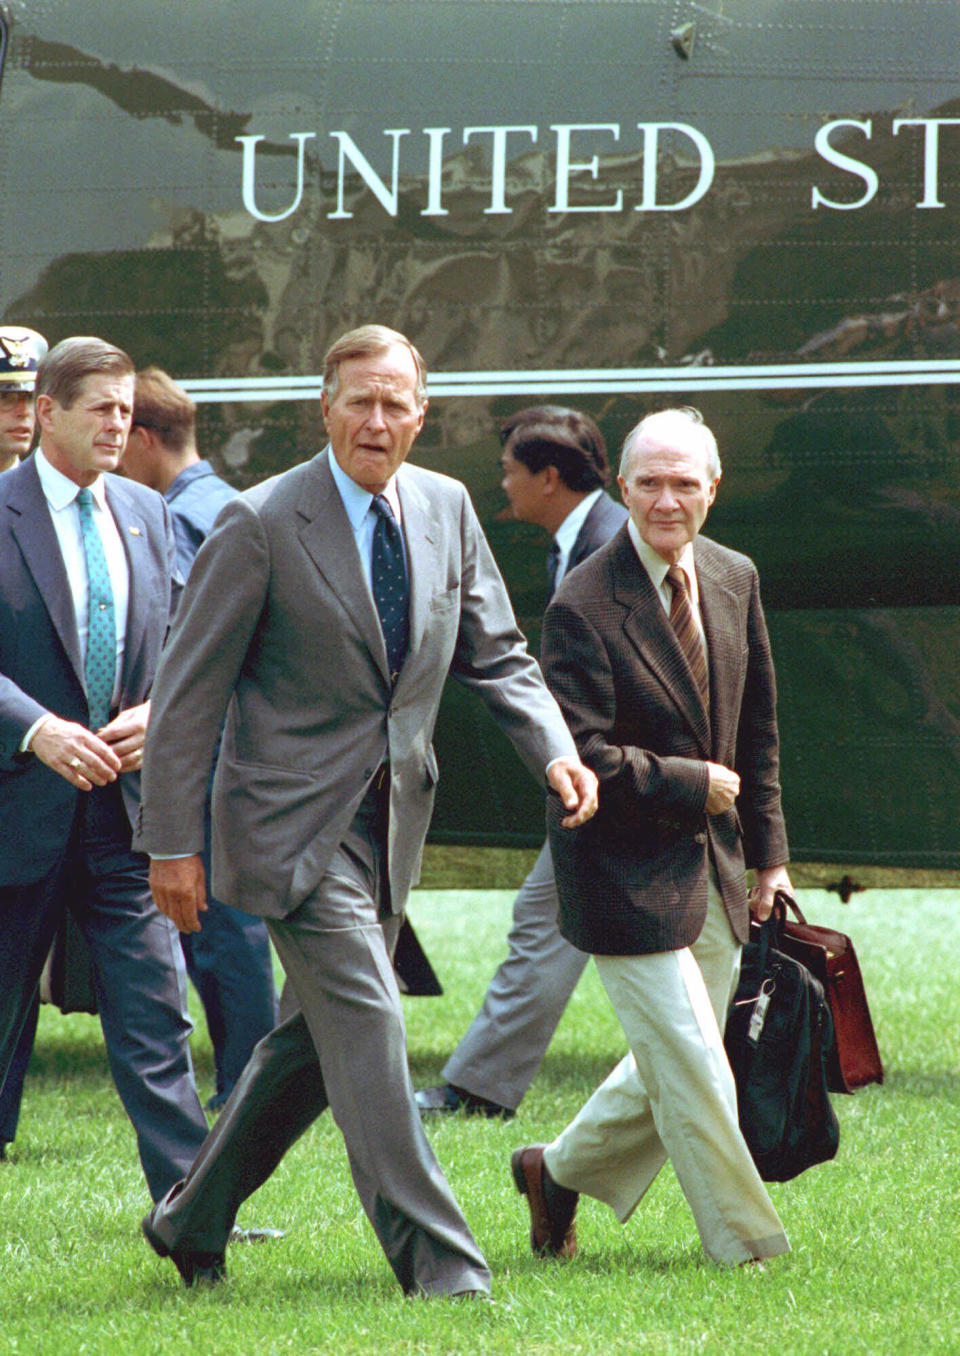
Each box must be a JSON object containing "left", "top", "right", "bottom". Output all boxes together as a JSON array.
[{"left": 443, "top": 843, "right": 590, "bottom": 1111}]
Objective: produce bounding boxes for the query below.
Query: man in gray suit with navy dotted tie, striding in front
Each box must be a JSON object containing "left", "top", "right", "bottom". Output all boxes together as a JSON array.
[{"left": 138, "top": 325, "right": 595, "bottom": 1295}]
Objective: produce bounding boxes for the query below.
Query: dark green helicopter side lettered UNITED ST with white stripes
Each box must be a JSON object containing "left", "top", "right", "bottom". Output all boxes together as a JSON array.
[{"left": 0, "top": 0, "right": 960, "bottom": 866}]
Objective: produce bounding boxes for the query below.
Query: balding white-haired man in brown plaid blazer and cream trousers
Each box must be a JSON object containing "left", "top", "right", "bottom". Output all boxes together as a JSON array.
[{"left": 513, "top": 410, "right": 791, "bottom": 1264}]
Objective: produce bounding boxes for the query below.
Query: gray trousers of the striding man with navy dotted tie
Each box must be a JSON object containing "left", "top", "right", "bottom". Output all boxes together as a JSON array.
[{"left": 146, "top": 797, "right": 489, "bottom": 1295}]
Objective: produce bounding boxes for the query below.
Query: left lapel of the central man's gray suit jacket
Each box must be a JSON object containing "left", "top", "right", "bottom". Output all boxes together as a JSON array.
[{"left": 297, "top": 452, "right": 393, "bottom": 683}]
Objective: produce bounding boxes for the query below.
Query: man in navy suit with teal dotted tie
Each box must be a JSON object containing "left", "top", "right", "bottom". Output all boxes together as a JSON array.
[{"left": 0, "top": 338, "right": 206, "bottom": 1199}]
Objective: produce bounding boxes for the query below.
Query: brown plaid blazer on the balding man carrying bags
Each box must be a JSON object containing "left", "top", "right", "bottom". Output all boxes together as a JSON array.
[{"left": 541, "top": 526, "right": 789, "bottom": 955}]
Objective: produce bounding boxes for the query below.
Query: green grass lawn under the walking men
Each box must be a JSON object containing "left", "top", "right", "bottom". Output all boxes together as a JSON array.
[{"left": 0, "top": 890, "right": 960, "bottom": 1356}]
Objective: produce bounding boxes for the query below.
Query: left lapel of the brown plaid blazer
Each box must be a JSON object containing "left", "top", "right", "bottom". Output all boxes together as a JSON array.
[{"left": 610, "top": 527, "right": 711, "bottom": 757}]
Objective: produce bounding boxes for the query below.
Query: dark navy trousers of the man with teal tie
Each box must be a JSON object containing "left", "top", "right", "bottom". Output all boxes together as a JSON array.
[{"left": 0, "top": 784, "right": 206, "bottom": 1200}]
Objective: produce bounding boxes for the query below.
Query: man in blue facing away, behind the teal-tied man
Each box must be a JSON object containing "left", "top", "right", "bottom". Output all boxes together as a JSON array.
[{"left": 121, "top": 367, "right": 277, "bottom": 1111}]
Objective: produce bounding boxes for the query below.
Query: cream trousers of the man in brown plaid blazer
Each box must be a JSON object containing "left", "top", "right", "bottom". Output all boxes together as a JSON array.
[{"left": 544, "top": 880, "right": 789, "bottom": 1265}]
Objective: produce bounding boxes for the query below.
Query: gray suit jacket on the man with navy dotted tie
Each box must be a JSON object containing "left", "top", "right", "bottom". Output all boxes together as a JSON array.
[{"left": 134, "top": 450, "right": 575, "bottom": 917}]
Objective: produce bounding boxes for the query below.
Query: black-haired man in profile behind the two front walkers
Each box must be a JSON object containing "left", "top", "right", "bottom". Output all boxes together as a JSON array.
[{"left": 416, "top": 405, "right": 626, "bottom": 1119}]
